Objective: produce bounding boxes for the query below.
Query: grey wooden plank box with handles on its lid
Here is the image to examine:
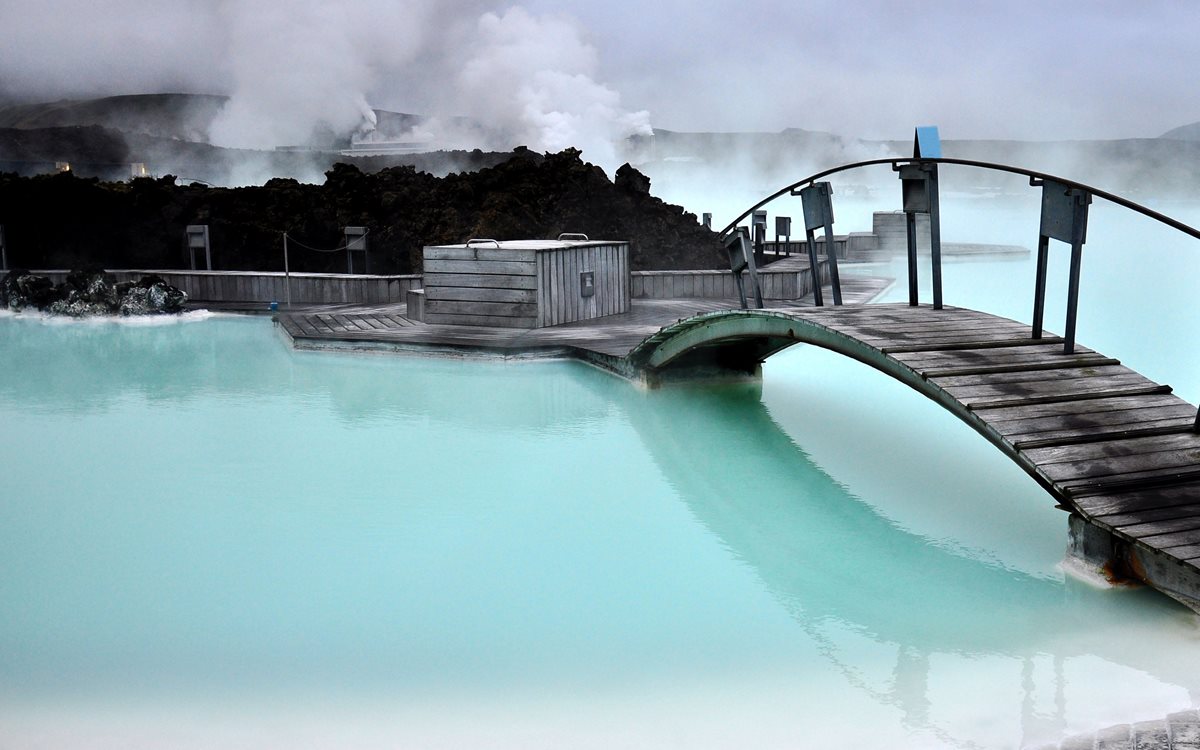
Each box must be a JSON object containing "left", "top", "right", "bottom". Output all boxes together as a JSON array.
[{"left": 422, "top": 235, "right": 630, "bottom": 328}]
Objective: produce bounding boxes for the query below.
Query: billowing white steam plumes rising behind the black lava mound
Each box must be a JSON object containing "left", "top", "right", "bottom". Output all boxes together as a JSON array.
[{"left": 211, "top": 0, "right": 652, "bottom": 168}]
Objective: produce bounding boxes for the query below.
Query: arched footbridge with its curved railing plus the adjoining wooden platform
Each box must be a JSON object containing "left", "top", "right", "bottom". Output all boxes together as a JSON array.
[{"left": 277, "top": 143, "right": 1200, "bottom": 611}]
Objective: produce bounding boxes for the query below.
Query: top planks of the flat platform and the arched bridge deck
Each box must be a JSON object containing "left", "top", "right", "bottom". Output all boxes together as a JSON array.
[{"left": 278, "top": 295, "right": 1200, "bottom": 569}]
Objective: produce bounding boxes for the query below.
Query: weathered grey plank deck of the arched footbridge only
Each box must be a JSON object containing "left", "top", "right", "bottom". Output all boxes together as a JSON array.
[{"left": 635, "top": 304, "right": 1200, "bottom": 607}]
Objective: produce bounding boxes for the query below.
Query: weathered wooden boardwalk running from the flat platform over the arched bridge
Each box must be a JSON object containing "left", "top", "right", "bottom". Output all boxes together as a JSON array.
[{"left": 278, "top": 283, "right": 1200, "bottom": 608}]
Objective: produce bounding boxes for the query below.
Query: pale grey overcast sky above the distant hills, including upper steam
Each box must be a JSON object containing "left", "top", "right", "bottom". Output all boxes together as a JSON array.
[{"left": 0, "top": 0, "right": 1200, "bottom": 139}]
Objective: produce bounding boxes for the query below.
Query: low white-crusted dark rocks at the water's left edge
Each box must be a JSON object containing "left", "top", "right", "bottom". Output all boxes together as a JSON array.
[{"left": 0, "top": 269, "right": 187, "bottom": 318}]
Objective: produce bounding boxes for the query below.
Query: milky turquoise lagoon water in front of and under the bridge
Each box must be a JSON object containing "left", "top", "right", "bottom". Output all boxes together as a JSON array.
[{"left": 0, "top": 195, "right": 1200, "bottom": 748}]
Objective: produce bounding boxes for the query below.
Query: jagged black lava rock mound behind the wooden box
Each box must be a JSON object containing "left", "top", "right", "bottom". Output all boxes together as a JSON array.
[{"left": 0, "top": 149, "right": 724, "bottom": 274}]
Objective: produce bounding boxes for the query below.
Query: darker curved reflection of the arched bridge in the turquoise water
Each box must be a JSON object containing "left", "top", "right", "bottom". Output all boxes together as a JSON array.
[{"left": 625, "top": 384, "right": 1200, "bottom": 746}]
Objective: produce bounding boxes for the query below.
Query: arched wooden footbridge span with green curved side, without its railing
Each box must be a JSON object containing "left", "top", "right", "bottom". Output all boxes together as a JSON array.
[{"left": 625, "top": 304, "right": 1200, "bottom": 608}]
